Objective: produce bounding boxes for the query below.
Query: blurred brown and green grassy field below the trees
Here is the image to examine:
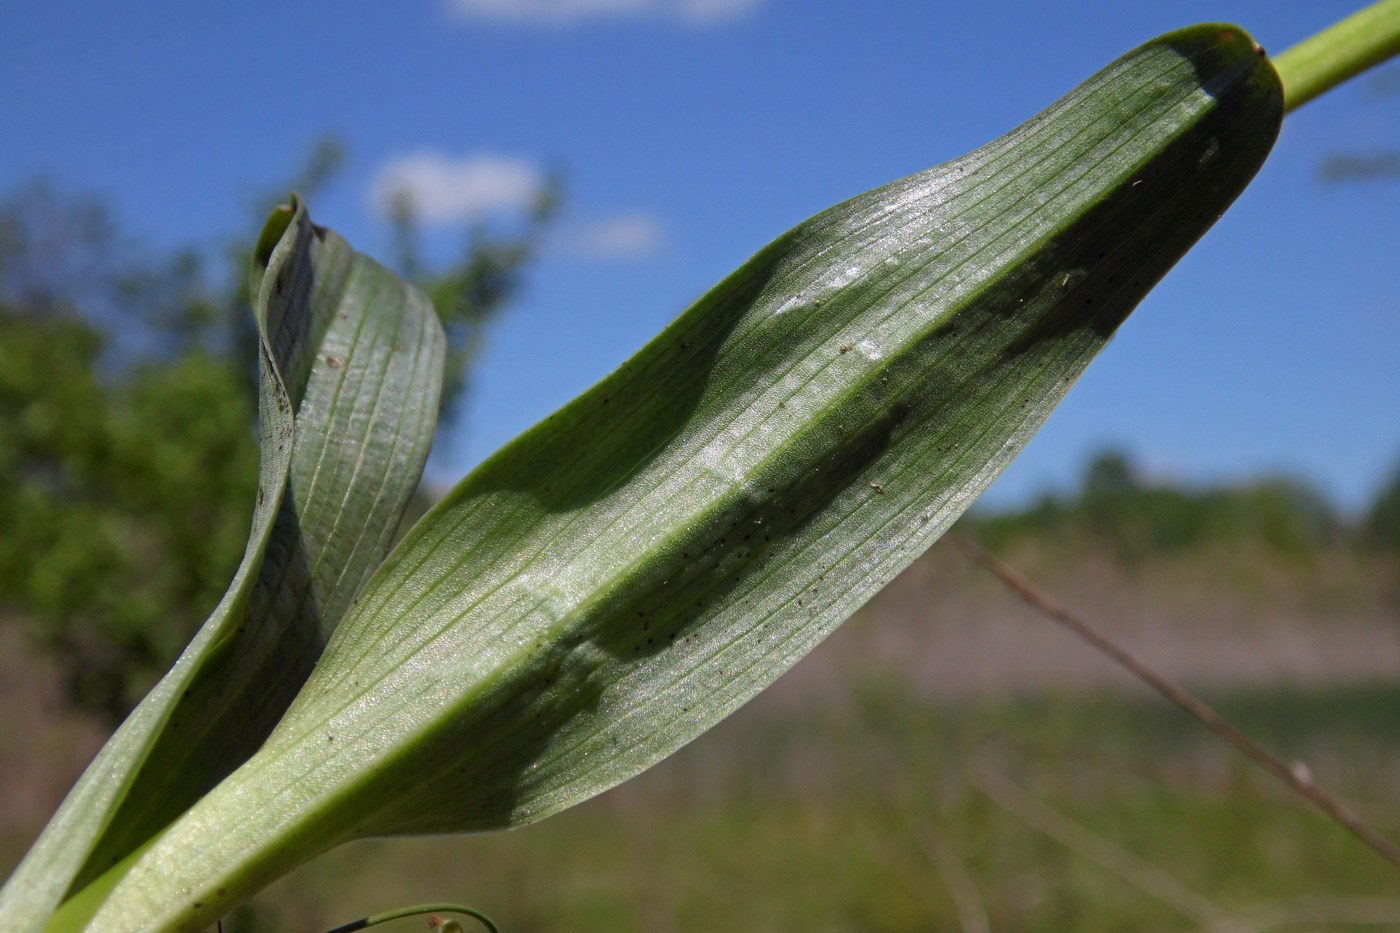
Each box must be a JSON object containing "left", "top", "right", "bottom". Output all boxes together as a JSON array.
[{"left": 0, "top": 544, "right": 1400, "bottom": 933}]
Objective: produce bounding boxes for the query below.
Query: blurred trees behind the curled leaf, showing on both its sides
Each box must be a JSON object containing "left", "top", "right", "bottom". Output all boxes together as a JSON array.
[{"left": 0, "top": 149, "right": 559, "bottom": 726}]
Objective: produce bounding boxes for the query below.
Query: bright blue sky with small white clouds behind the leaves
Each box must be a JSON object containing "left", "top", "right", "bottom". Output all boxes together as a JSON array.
[{"left": 0, "top": 0, "right": 1400, "bottom": 509}]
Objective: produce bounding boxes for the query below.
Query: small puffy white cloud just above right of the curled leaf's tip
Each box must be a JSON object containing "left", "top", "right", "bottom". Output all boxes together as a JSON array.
[{"left": 370, "top": 150, "right": 545, "bottom": 224}]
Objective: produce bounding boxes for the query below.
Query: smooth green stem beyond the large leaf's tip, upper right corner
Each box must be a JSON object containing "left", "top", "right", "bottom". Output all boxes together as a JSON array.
[{"left": 1274, "top": 0, "right": 1400, "bottom": 113}]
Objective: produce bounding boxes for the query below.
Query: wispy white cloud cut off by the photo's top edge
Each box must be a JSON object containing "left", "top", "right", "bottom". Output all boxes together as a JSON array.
[{"left": 447, "top": 0, "right": 766, "bottom": 28}]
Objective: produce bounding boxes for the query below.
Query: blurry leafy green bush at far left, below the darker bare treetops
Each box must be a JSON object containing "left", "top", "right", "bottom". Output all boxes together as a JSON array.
[{"left": 0, "top": 304, "right": 258, "bottom": 724}]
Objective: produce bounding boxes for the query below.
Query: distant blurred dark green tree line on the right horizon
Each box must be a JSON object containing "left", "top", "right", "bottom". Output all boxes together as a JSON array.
[{"left": 967, "top": 451, "right": 1400, "bottom": 560}]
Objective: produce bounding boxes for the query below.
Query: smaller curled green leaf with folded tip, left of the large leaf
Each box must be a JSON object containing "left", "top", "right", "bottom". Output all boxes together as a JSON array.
[{"left": 0, "top": 205, "right": 444, "bottom": 930}]
